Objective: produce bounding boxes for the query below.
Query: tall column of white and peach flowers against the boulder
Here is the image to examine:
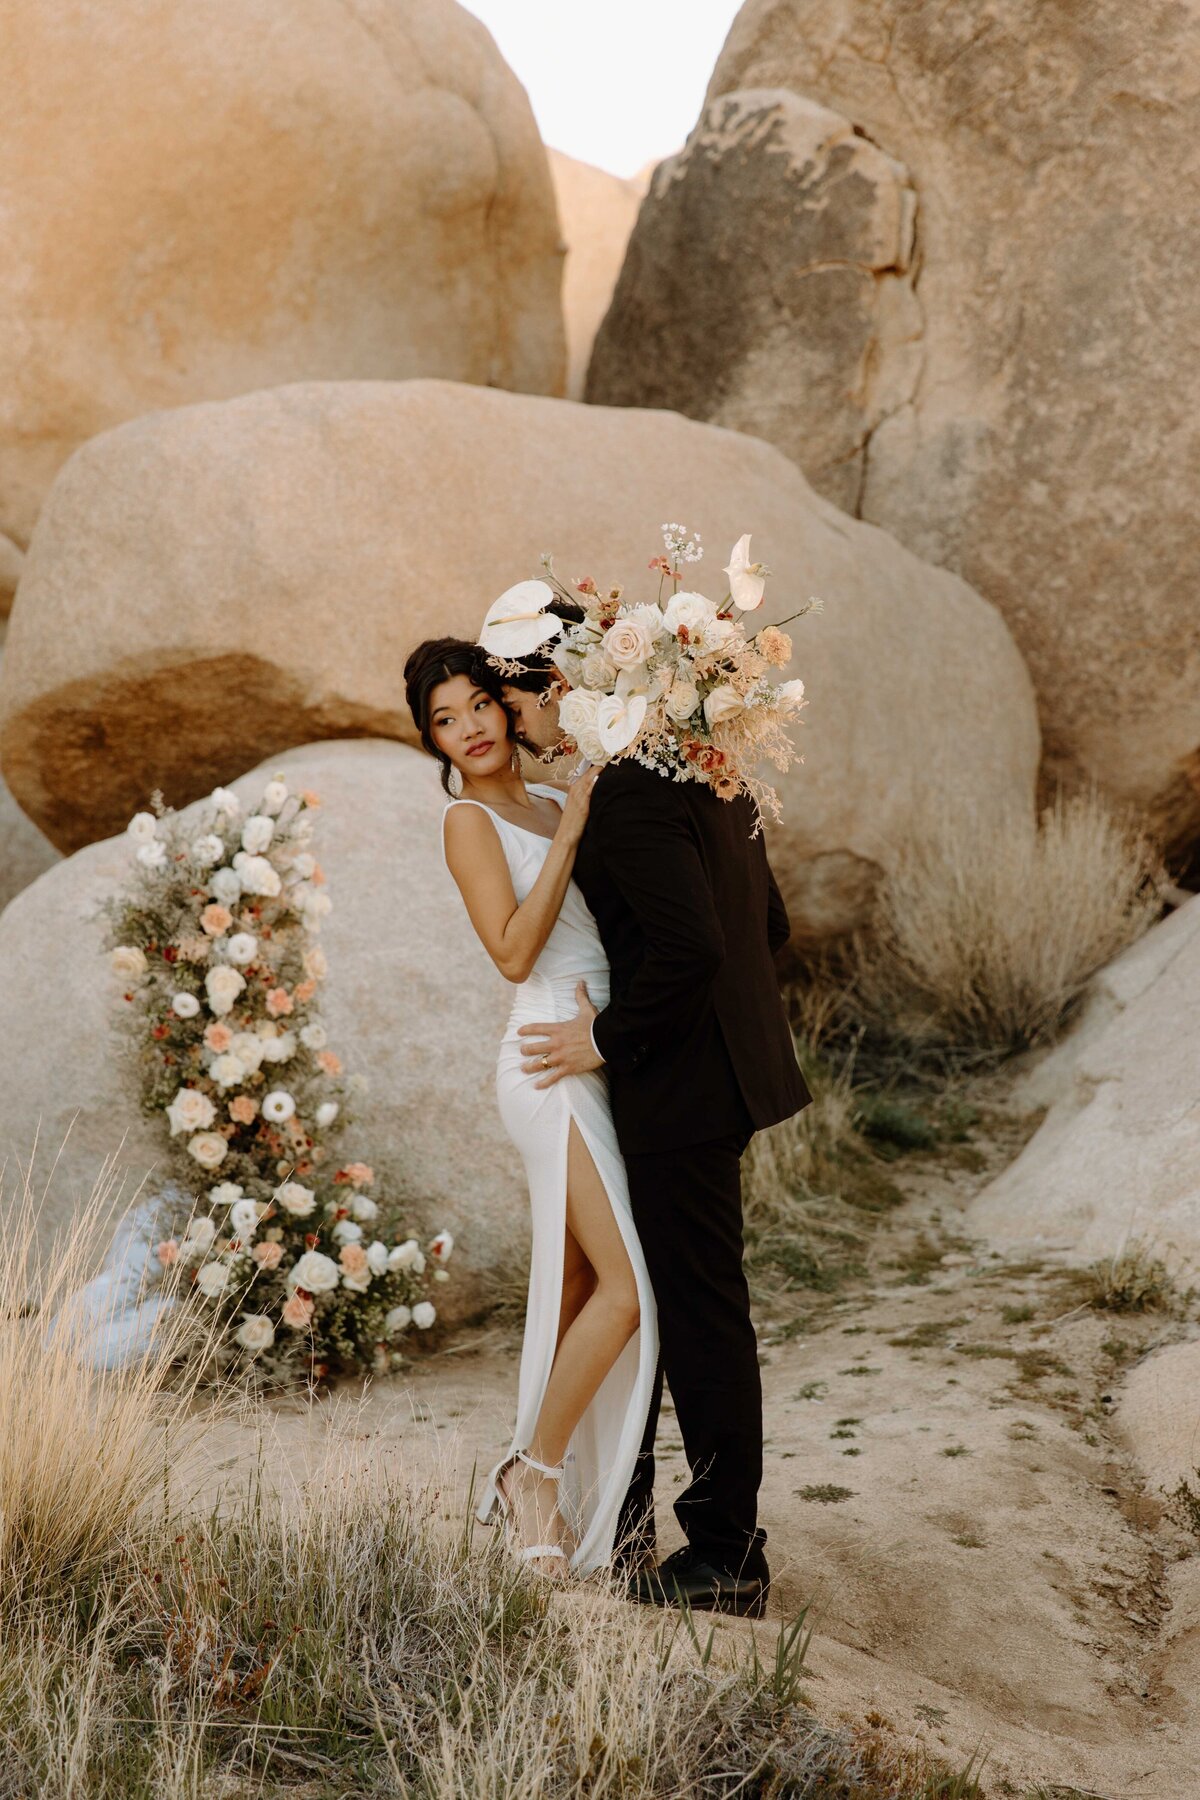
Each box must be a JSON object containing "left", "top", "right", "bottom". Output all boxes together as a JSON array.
[{"left": 104, "top": 776, "right": 453, "bottom": 1381}]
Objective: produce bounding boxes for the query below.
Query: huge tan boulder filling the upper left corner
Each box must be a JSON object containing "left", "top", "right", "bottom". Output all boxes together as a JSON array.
[{"left": 0, "top": 0, "right": 563, "bottom": 607}]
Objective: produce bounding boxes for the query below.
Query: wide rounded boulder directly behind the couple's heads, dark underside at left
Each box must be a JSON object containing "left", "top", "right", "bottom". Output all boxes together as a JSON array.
[{"left": 0, "top": 382, "right": 1038, "bottom": 936}]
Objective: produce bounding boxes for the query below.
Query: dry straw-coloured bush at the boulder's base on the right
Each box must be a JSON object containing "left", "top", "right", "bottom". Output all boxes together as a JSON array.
[{"left": 827, "top": 794, "right": 1164, "bottom": 1062}]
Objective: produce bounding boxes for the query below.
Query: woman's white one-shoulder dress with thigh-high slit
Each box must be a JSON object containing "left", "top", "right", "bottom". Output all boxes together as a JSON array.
[{"left": 443, "top": 785, "right": 658, "bottom": 1575}]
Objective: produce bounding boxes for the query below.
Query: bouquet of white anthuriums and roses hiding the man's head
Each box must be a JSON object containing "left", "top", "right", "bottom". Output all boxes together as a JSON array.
[{"left": 480, "top": 524, "right": 820, "bottom": 830}]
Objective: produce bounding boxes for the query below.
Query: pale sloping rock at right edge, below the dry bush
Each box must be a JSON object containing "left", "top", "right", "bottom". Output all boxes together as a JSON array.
[{"left": 968, "top": 898, "right": 1200, "bottom": 1285}]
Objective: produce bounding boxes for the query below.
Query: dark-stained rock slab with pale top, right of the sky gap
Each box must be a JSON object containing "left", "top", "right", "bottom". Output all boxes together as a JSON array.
[{"left": 587, "top": 88, "right": 921, "bottom": 513}]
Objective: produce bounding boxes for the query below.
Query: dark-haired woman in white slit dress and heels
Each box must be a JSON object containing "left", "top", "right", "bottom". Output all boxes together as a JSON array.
[{"left": 405, "top": 637, "right": 658, "bottom": 1580}]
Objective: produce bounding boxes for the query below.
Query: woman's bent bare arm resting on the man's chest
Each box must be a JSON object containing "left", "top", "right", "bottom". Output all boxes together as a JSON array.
[{"left": 444, "top": 770, "right": 599, "bottom": 981}]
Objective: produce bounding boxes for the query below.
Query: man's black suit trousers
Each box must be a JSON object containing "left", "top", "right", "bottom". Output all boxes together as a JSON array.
[{"left": 617, "top": 1120, "right": 766, "bottom": 1575}]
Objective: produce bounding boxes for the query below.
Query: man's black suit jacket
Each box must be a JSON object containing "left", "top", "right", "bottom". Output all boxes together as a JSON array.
[{"left": 574, "top": 761, "right": 811, "bottom": 1154}]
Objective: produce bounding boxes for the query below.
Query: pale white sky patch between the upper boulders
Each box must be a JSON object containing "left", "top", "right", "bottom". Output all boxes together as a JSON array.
[{"left": 462, "top": 0, "right": 739, "bottom": 175}]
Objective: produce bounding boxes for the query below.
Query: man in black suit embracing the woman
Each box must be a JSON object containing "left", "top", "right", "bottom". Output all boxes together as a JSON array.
[{"left": 492, "top": 608, "right": 811, "bottom": 1616}]
